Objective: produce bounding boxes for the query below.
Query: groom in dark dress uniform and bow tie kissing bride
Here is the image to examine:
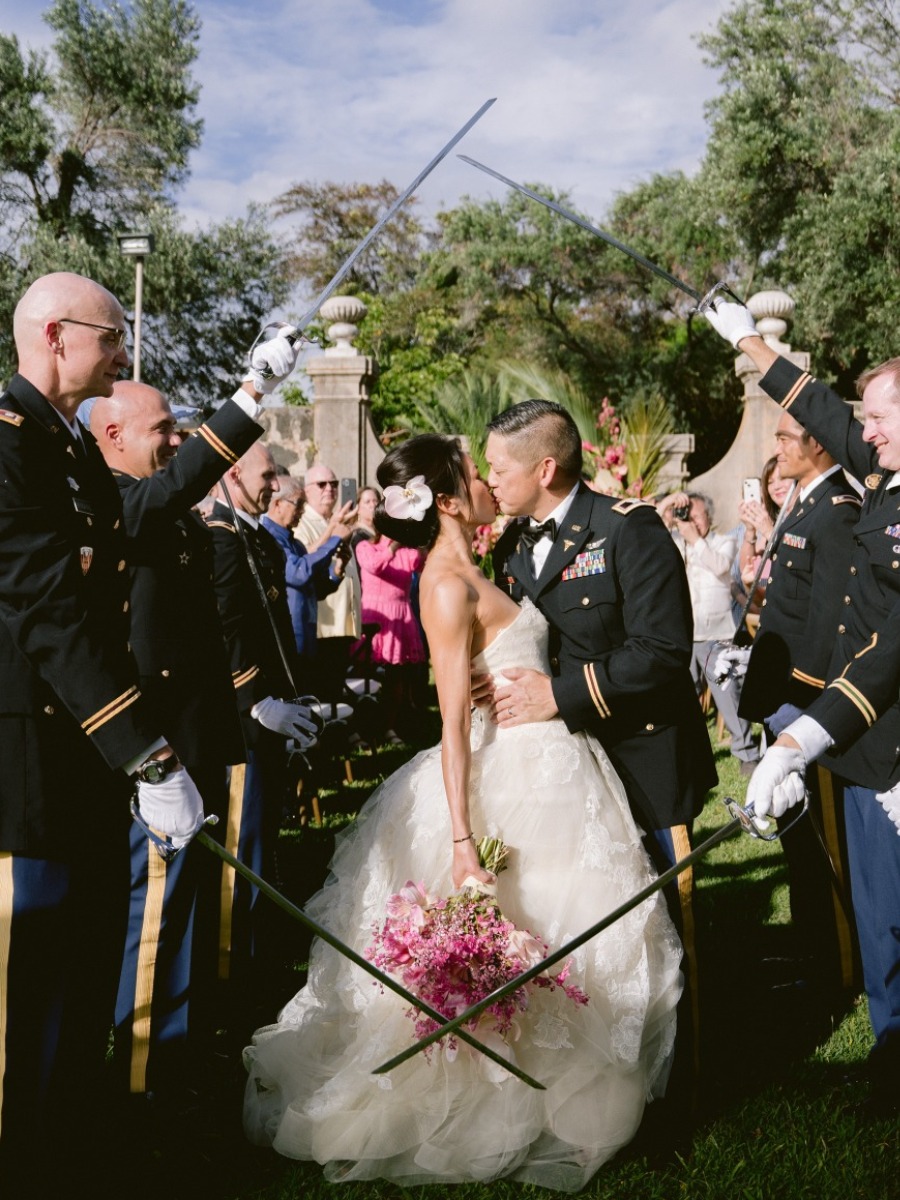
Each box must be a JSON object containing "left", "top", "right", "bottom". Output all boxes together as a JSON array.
[{"left": 486, "top": 400, "right": 716, "bottom": 1128}]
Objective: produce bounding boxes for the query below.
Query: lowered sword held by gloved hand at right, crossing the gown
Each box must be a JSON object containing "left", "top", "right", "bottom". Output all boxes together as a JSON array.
[{"left": 372, "top": 796, "right": 809, "bottom": 1075}]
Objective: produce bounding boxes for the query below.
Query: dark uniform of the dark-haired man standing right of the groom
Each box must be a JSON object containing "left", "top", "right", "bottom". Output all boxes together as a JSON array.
[{"left": 740, "top": 470, "right": 860, "bottom": 989}]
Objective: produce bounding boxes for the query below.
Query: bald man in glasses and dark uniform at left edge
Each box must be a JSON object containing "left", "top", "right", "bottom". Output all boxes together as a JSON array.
[{"left": 0, "top": 272, "right": 203, "bottom": 1200}]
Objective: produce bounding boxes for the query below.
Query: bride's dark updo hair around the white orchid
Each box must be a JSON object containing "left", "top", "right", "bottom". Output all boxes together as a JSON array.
[{"left": 374, "top": 433, "right": 469, "bottom": 550}]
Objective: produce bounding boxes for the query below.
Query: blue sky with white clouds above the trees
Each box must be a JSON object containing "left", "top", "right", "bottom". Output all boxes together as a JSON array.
[{"left": 0, "top": 0, "right": 732, "bottom": 234}]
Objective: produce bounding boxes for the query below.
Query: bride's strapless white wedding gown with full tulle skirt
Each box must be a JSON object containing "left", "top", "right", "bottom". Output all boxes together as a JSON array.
[{"left": 244, "top": 602, "right": 682, "bottom": 1192}]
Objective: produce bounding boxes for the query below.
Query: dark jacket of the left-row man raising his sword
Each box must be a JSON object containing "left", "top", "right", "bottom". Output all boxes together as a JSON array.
[{"left": 115, "top": 400, "right": 263, "bottom": 778}]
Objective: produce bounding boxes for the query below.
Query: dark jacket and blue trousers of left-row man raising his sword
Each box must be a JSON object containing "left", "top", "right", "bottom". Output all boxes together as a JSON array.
[{"left": 115, "top": 400, "right": 262, "bottom": 1093}]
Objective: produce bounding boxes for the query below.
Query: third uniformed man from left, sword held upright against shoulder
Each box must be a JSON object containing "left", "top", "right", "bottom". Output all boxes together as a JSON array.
[{"left": 206, "top": 443, "right": 314, "bottom": 1045}]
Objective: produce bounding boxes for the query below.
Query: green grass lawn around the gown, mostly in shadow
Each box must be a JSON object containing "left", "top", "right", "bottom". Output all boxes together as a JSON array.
[{"left": 130, "top": 720, "right": 900, "bottom": 1200}]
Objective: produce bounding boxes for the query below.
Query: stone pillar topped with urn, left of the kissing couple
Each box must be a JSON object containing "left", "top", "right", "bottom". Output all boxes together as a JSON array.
[{"left": 306, "top": 296, "right": 384, "bottom": 487}]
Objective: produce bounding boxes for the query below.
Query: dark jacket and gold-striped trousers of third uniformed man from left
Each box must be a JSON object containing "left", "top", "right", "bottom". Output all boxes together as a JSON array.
[{"left": 206, "top": 503, "right": 304, "bottom": 1039}]
